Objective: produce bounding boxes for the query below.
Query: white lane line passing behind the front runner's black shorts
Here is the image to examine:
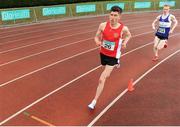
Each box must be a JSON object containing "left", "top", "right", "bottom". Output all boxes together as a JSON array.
[{"left": 0, "top": 34, "right": 179, "bottom": 125}]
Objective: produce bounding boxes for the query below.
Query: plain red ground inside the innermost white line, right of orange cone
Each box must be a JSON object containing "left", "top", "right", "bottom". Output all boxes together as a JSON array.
[{"left": 93, "top": 46, "right": 180, "bottom": 126}]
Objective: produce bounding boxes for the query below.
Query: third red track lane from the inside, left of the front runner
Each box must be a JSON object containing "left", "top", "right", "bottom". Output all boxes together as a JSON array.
[{"left": 0, "top": 24, "right": 157, "bottom": 86}]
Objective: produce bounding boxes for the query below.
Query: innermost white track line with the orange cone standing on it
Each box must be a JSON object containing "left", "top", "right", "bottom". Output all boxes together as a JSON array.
[{"left": 88, "top": 49, "right": 180, "bottom": 127}]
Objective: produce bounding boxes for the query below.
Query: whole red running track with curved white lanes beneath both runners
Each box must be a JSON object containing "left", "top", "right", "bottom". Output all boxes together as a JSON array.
[{"left": 0, "top": 11, "right": 180, "bottom": 126}]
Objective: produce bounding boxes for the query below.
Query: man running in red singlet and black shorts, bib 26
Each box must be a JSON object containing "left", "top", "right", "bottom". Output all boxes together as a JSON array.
[{"left": 88, "top": 6, "right": 131, "bottom": 109}]
